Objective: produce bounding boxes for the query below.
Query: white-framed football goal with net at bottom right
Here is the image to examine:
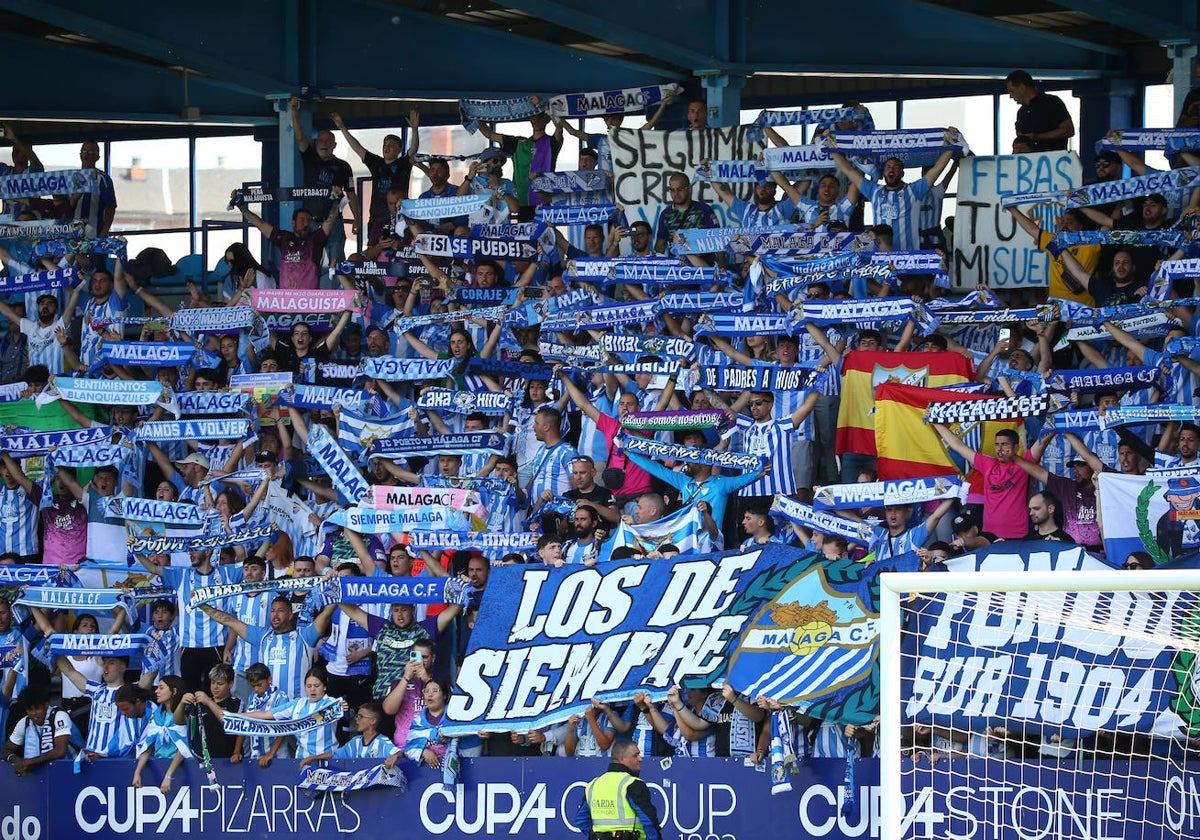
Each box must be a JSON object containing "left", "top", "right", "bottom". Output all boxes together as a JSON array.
[{"left": 880, "top": 564, "right": 1200, "bottom": 840}]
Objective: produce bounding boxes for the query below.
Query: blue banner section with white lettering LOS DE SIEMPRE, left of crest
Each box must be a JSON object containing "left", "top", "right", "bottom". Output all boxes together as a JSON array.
[{"left": 442, "top": 546, "right": 804, "bottom": 736}]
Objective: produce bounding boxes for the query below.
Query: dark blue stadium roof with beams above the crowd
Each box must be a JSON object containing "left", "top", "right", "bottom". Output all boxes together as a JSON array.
[{"left": 0, "top": 0, "right": 1200, "bottom": 136}]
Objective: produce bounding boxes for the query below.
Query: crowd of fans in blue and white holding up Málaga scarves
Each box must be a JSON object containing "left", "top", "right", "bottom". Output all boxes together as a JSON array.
[{"left": 0, "top": 73, "right": 1200, "bottom": 787}]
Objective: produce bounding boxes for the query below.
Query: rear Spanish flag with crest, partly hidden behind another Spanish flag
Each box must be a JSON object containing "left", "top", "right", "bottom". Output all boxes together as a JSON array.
[{"left": 838, "top": 350, "right": 974, "bottom": 456}]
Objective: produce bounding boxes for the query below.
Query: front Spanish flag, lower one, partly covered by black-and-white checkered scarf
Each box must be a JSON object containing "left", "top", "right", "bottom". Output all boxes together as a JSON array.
[{"left": 875, "top": 382, "right": 1021, "bottom": 481}]
